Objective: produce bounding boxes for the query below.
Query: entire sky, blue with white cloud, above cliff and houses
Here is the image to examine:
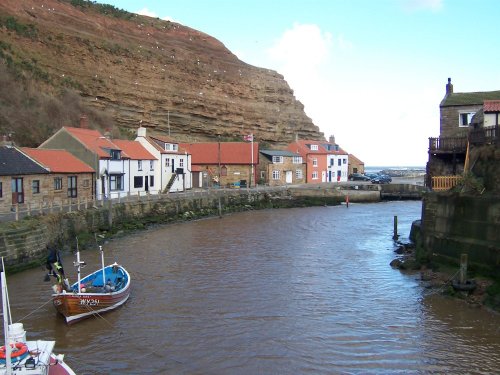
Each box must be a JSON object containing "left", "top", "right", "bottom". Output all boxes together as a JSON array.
[{"left": 99, "top": 0, "right": 500, "bottom": 166}]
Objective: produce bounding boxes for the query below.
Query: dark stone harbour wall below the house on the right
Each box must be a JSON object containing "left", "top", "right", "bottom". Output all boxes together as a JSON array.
[{"left": 421, "top": 193, "right": 500, "bottom": 275}]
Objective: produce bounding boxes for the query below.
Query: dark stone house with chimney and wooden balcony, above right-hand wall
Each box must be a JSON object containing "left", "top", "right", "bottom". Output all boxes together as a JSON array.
[{"left": 426, "top": 78, "right": 500, "bottom": 187}]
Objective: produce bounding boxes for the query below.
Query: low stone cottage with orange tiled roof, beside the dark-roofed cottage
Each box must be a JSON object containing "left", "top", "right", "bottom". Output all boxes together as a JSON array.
[{"left": 21, "top": 147, "right": 95, "bottom": 202}]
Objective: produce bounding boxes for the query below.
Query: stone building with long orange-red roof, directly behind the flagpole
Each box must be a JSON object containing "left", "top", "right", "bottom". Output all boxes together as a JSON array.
[{"left": 180, "top": 142, "right": 259, "bottom": 187}]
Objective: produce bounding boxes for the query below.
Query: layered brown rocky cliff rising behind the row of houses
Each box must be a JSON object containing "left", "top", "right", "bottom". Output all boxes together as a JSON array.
[{"left": 0, "top": 0, "right": 324, "bottom": 144}]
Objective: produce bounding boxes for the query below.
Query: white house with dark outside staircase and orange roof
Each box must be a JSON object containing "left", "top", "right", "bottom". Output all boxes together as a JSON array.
[{"left": 135, "top": 127, "right": 192, "bottom": 192}]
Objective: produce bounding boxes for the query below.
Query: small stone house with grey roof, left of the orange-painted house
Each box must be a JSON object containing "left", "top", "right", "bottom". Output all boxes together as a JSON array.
[{"left": 257, "top": 150, "right": 306, "bottom": 186}]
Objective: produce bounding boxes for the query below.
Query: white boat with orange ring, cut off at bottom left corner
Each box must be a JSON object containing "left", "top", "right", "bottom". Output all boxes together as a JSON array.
[{"left": 0, "top": 259, "right": 76, "bottom": 375}]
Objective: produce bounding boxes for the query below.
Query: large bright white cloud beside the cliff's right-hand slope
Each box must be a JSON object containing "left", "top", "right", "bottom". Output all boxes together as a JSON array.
[{"left": 268, "top": 24, "right": 434, "bottom": 166}]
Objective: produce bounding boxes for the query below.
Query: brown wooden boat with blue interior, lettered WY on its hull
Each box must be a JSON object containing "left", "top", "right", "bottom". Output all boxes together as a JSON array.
[{"left": 52, "top": 266, "right": 130, "bottom": 324}]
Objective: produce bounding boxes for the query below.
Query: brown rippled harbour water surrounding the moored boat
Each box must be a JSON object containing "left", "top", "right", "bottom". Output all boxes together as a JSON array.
[{"left": 3, "top": 201, "right": 500, "bottom": 375}]
